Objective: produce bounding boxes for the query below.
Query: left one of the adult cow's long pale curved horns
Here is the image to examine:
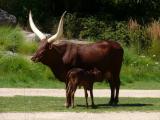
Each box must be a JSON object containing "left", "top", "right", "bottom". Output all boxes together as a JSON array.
[{"left": 29, "top": 11, "right": 46, "bottom": 40}]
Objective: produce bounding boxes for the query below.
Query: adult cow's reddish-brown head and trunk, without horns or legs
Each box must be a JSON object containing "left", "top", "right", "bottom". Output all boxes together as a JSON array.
[{"left": 32, "top": 40, "right": 123, "bottom": 82}]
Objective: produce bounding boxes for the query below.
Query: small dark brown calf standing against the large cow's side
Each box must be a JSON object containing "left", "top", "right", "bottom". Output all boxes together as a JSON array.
[{"left": 66, "top": 68, "right": 102, "bottom": 108}]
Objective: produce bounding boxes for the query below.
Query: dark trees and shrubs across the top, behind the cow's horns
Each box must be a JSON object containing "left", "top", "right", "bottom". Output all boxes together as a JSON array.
[{"left": 0, "top": 0, "right": 160, "bottom": 51}]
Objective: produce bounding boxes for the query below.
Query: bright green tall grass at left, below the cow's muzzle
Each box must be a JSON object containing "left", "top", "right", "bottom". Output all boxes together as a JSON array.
[{"left": 0, "top": 53, "right": 63, "bottom": 87}]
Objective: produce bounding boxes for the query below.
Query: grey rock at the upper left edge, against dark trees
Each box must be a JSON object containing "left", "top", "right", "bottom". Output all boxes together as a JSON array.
[{"left": 0, "top": 9, "right": 17, "bottom": 25}]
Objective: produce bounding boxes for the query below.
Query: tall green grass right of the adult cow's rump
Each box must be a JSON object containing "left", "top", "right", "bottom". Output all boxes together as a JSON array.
[{"left": 121, "top": 49, "right": 160, "bottom": 85}]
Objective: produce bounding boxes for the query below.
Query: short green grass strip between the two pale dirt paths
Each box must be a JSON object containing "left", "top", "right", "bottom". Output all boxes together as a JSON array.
[{"left": 0, "top": 96, "right": 160, "bottom": 112}]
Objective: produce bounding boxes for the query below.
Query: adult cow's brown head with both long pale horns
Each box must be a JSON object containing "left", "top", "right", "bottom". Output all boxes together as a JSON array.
[{"left": 29, "top": 11, "right": 66, "bottom": 63}]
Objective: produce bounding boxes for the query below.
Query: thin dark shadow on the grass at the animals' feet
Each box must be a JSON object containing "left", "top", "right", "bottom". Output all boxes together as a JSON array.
[{"left": 77, "top": 103, "right": 153, "bottom": 109}]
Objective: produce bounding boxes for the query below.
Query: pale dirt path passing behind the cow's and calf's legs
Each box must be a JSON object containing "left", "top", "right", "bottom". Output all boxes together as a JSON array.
[{"left": 0, "top": 88, "right": 160, "bottom": 98}]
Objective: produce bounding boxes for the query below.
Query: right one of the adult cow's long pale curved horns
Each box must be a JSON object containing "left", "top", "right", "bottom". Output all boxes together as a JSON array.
[{"left": 48, "top": 11, "right": 67, "bottom": 43}]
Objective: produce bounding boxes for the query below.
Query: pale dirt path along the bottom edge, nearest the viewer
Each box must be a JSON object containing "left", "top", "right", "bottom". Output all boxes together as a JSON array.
[{"left": 0, "top": 112, "right": 160, "bottom": 120}]
